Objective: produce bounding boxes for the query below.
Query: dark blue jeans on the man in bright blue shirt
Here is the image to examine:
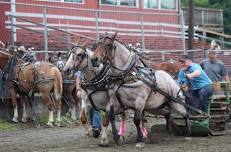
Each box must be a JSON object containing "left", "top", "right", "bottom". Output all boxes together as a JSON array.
[{"left": 192, "top": 85, "right": 213, "bottom": 112}]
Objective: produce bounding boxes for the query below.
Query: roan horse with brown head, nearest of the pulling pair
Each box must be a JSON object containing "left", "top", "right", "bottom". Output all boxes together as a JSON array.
[{"left": 92, "top": 32, "right": 191, "bottom": 147}]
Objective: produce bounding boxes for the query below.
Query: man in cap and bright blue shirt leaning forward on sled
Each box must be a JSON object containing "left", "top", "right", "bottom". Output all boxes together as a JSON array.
[{"left": 178, "top": 54, "right": 213, "bottom": 112}]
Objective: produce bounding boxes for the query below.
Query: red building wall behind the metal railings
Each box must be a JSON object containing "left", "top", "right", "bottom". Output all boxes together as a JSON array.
[{"left": 3, "top": 0, "right": 182, "bottom": 49}]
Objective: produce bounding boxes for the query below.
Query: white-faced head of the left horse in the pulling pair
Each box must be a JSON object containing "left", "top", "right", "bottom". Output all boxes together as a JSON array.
[{"left": 63, "top": 45, "right": 88, "bottom": 72}]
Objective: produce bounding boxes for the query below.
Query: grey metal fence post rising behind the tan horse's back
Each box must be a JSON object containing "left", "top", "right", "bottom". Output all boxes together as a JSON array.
[{"left": 43, "top": 6, "right": 49, "bottom": 61}]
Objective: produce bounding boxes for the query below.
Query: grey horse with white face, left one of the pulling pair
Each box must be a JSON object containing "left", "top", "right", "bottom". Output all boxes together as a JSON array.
[{"left": 63, "top": 46, "right": 125, "bottom": 146}]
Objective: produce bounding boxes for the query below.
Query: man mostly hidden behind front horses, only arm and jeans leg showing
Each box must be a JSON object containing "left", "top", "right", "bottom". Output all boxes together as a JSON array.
[{"left": 75, "top": 71, "right": 102, "bottom": 138}]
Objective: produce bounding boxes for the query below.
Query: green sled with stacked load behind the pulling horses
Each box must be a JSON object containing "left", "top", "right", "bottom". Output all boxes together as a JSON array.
[{"left": 171, "top": 82, "right": 231, "bottom": 136}]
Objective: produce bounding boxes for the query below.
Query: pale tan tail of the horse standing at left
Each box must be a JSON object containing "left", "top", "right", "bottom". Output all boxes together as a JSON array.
[{"left": 52, "top": 67, "right": 63, "bottom": 100}]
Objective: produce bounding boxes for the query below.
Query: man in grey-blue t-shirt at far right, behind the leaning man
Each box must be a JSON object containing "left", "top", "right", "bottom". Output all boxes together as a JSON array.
[{"left": 200, "top": 50, "right": 229, "bottom": 82}]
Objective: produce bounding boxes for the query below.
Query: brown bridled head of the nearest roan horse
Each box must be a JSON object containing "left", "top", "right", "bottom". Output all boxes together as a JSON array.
[{"left": 91, "top": 32, "right": 117, "bottom": 66}]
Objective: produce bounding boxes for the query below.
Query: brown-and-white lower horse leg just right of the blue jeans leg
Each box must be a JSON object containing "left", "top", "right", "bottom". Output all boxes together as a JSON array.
[{"left": 99, "top": 111, "right": 110, "bottom": 147}]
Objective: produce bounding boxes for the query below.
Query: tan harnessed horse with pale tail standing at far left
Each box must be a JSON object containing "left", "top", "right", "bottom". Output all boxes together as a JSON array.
[{"left": 0, "top": 52, "right": 63, "bottom": 126}]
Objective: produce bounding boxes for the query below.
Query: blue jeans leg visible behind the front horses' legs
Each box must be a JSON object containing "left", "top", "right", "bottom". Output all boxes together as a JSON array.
[{"left": 89, "top": 108, "right": 102, "bottom": 130}]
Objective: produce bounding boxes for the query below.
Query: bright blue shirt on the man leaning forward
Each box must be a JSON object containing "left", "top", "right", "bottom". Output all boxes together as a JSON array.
[{"left": 178, "top": 63, "right": 212, "bottom": 90}]
